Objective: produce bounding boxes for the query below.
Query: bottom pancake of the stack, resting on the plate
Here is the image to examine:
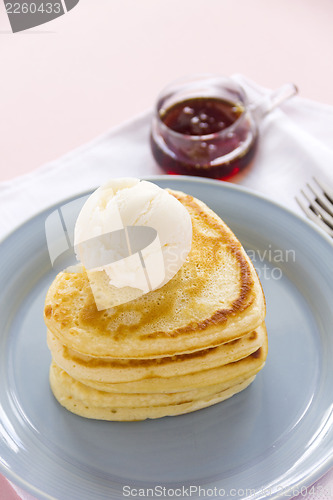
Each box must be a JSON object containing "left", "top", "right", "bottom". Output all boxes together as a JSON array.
[{"left": 50, "top": 363, "right": 254, "bottom": 421}]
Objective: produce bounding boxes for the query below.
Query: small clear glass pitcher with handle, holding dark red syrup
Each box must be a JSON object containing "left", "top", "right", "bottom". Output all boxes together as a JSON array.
[{"left": 151, "top": 76, "right": 295, "bottom": 179}]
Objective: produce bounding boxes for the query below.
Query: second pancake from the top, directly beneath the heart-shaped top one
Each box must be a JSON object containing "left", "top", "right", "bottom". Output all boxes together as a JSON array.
[{"left": 47, "top": 325, "right": 265, "bottom": 383}]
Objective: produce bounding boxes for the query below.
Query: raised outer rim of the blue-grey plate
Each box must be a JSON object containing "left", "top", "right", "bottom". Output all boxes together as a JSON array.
[{"left": 0, "top": 175, "right": 333, "bottom": 500}]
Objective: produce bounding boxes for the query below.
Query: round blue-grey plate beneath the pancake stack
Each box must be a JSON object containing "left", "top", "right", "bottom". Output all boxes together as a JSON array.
[{"left": 0, "top": 177, "right": 333, "bottom": 500}]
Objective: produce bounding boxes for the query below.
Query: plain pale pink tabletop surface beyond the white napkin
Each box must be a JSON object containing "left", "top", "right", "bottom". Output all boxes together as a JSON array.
[{"left": 0, "top": 0, "right": 333, "bottom": 500}]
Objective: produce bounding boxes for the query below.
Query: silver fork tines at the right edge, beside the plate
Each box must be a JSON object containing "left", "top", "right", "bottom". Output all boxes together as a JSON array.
[{"left": 296, "top": 177, "right": 333, "bottom": 238}]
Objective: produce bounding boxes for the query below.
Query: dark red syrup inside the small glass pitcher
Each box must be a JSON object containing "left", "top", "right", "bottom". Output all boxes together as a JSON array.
[{"left": 151, "top": 97, "right": 256, "bottom": 179}]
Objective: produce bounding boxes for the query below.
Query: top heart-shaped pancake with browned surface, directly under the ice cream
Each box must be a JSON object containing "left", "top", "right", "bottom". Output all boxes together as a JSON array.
[{"left": 44, "top": 191, "right": 265, "bottom": 359}]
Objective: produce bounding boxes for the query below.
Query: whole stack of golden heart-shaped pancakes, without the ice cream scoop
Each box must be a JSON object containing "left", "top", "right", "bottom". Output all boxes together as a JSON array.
[{"left": 44, "top": 191, "right": 267, "bottom": 420}]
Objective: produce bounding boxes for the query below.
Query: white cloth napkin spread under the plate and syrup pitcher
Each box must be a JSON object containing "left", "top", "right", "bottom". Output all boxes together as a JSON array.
[{"left": 0, "top": 75, "right": 333, "bottom": 500}]
